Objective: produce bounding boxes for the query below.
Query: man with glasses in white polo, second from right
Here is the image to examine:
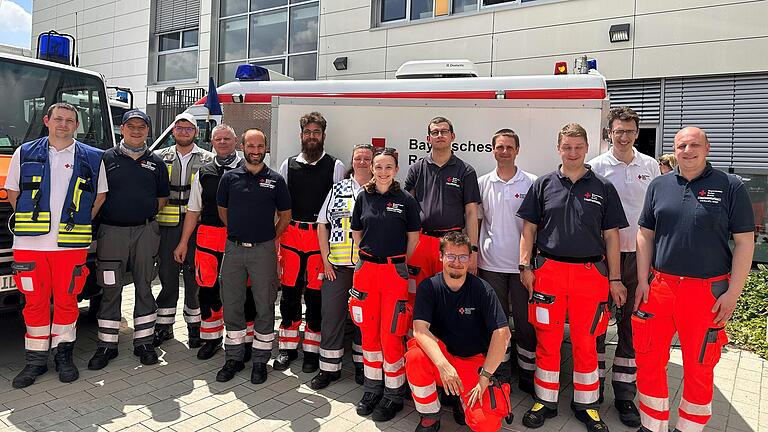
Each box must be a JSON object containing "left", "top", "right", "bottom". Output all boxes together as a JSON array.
[{"left": 589, "top": 107, "right": 659, "bottom": 427}]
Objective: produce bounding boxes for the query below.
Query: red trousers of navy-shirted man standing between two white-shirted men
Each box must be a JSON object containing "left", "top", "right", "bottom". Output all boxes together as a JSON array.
[{"left": 528, "top": 259, "right": 608, "bottom": 409}]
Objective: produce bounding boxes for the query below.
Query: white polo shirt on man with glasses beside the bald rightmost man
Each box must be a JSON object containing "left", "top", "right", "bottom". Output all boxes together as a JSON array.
[{"left": 587, "top": 147, "right": 661, "bottom": 252}]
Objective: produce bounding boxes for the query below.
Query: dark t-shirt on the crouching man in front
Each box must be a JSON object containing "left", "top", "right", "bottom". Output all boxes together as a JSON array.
[{"left": 413, "top": 272, "right": 509, "bottom": 357}]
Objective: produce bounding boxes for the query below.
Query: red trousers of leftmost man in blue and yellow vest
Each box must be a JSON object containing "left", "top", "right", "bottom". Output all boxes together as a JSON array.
[{"left": 13, "top": 249, "right": 88, "bottom": 351}]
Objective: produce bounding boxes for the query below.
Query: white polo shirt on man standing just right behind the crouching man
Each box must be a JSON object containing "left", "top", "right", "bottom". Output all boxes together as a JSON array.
[{"left": 477, "top": 167, "right": 536, "bottom": 273}]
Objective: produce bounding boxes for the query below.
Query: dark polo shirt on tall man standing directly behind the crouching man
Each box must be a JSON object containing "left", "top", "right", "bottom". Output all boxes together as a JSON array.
[{"left": 405, "top": 154, "right": 482, "bottom": 231}]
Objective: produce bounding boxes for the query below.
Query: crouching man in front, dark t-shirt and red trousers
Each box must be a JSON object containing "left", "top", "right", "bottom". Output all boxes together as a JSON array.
[{"left": 405, "top": 232, "right": 510, "bottom": 432}]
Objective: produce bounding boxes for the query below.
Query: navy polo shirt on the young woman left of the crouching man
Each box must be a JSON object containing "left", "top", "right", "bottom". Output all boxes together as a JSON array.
[{"left": 352, "top": 189, "right": 421, "bottom": 258}]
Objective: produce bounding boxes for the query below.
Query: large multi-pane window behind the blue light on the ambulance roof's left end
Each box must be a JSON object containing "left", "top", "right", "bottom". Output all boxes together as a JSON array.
[{"left": 218, "top": 0, "right": 319, "bottom": 84}]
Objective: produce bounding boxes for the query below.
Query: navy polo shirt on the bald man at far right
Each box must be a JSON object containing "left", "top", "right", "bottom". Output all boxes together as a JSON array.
[{"left": 636, "top": 162, "right": 755, "bottom": 278}]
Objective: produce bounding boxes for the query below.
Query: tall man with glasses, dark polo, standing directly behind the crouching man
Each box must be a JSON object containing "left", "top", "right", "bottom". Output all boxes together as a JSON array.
[{"left": 405, "top": 117, "right": 481, "bottom": 304}]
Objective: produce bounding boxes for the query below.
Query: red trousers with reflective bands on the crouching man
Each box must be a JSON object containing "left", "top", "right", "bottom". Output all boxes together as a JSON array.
[{"left": 405, "top": 338, "right": 511, "bottom": 431}]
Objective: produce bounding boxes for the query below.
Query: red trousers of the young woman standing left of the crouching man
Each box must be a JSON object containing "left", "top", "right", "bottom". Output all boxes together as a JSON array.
[{"left": 349, "top": 252, "right": 410, "bottom": 395}]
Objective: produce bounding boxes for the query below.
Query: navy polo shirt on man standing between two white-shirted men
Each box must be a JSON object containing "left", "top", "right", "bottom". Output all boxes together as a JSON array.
[{"left": 517, "top": 165, "right": 629, "bottom": 258}]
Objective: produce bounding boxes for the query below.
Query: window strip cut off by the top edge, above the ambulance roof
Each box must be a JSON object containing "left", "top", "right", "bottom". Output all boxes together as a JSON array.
[{"left": 374, "top": 0, "right": 539, "bottom": 23}]
